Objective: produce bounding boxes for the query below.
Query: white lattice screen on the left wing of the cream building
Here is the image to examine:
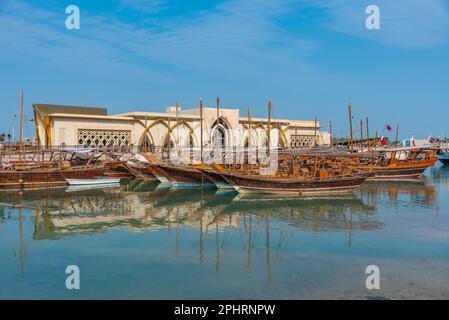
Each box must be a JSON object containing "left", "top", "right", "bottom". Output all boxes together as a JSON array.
[{"left": 78, "top": 129, "right": 131, "bottom": 147}]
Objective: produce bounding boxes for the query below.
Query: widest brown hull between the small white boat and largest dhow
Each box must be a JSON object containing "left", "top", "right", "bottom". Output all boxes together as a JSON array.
[{"left": 153, "top": 164, "right": 213, "bottom": 187}]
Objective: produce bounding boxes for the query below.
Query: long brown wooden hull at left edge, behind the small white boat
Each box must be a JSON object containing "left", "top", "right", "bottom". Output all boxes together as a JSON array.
[{"left": 0, "top": 167, "right": 106, "bottom": 189}]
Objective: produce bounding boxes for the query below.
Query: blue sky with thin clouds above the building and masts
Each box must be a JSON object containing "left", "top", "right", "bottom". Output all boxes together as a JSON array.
[{"left": 0, "top": 0, "right": 449, "bottom": 138}]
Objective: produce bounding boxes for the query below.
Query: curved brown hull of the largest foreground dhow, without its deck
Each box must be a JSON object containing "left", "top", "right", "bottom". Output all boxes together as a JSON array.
[{"left": 221, "top": 173, "right": 367, "bottom": 197}]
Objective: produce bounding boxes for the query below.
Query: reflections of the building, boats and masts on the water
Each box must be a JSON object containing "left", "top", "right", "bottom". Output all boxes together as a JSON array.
[{"left": 0, "top": 176, "right": 438, "bottom": 283}]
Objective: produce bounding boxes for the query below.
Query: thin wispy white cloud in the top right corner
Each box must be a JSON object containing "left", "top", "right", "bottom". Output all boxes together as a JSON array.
[{"left": 320, "top": 0, "right": 449, "bottom": 48}]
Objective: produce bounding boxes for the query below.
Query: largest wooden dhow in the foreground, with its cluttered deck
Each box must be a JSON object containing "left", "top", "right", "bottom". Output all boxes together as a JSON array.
[{"left": 206, "top": 150, "right": 373, "bottom": 197}]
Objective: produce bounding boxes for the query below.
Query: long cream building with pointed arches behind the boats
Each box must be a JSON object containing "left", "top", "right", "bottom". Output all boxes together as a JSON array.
[{"left": 33, "top": 104, "right": 330, "bottom": 151}]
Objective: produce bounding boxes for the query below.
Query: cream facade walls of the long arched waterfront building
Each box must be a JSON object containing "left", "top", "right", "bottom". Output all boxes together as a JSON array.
[{"left": 39, "top": 108, "right": 329, "bottom": 146}]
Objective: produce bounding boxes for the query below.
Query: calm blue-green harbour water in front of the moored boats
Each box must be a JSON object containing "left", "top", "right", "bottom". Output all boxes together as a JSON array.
[{"left": 0, "top": 167, "right": 449, "bottom": 299}]
